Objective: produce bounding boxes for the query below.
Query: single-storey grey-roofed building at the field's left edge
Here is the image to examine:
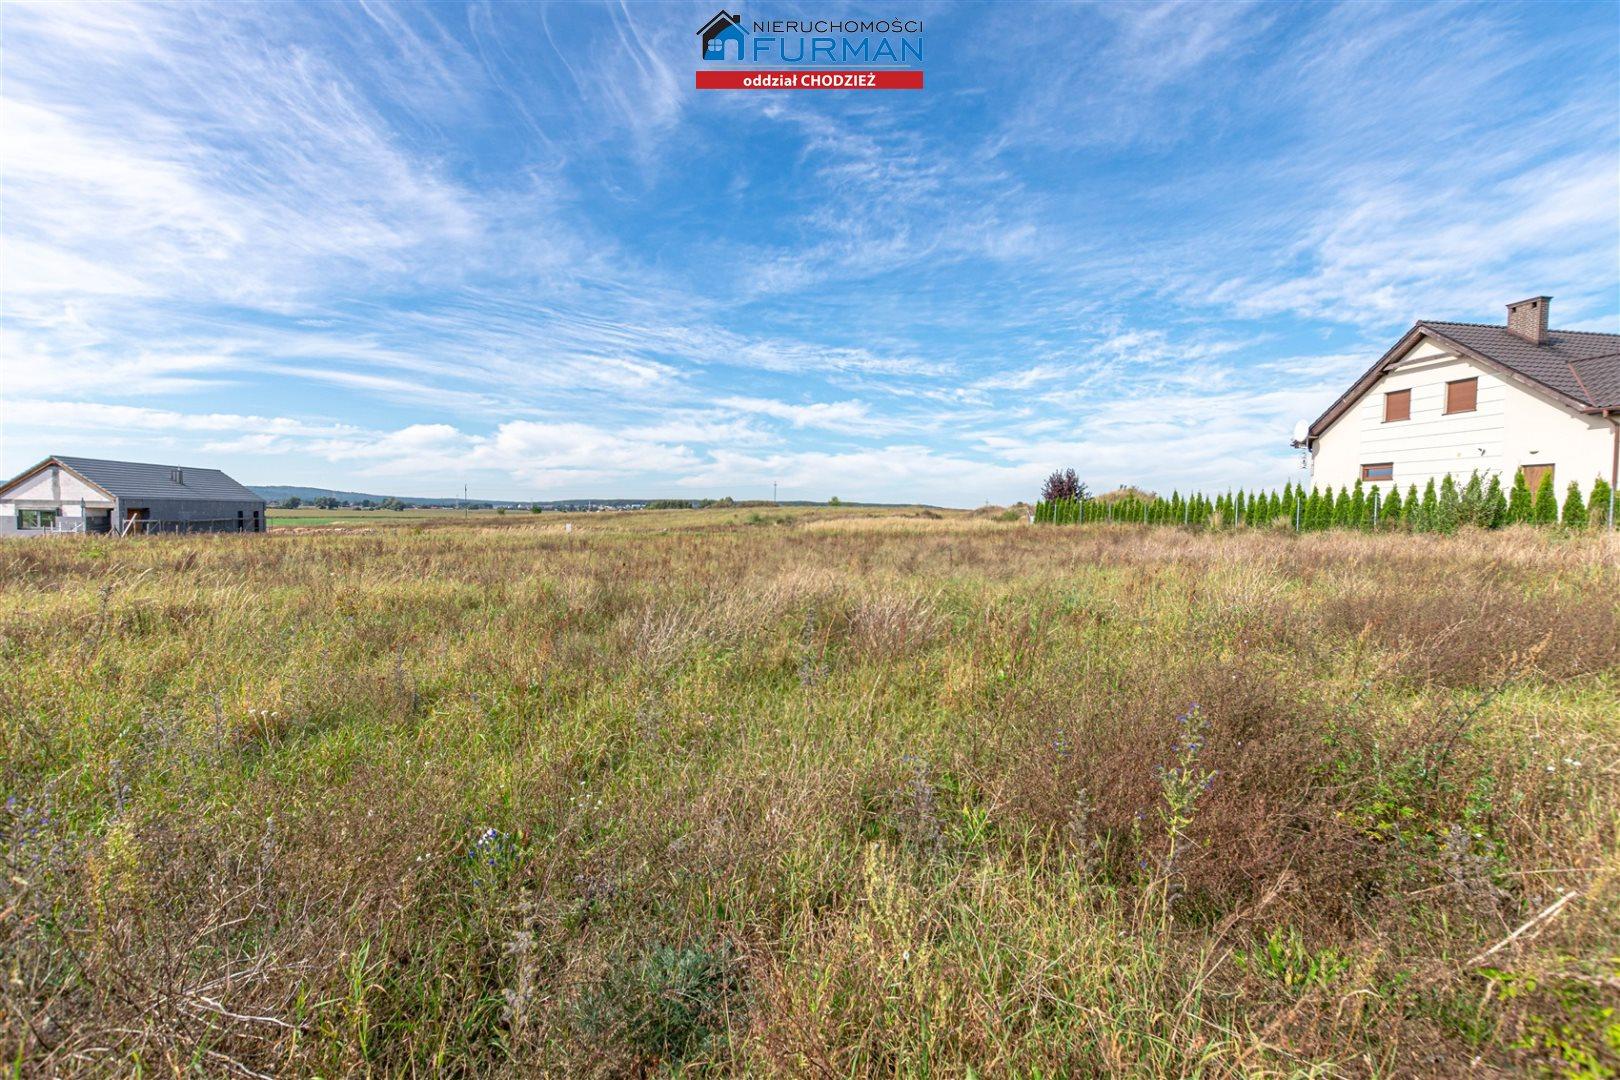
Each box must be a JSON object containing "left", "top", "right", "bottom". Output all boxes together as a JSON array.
[{"left": 0, "top": 457, "right": 267, "bottom": 536}]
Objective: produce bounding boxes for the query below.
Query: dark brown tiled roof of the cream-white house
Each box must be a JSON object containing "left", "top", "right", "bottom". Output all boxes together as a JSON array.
[{"left": 1311, "top": 321, "right": 1620, "bottom": 439}]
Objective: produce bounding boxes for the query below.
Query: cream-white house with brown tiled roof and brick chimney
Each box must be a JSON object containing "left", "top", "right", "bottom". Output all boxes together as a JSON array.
[{"left": 1294, "top": 296, "right": 1620, "bottom": 499}]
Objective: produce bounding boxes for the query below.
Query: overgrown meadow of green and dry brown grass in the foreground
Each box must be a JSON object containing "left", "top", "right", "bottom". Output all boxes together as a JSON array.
[{"left": 0, "top": 510, "right": 1620, "bottom": 1077}]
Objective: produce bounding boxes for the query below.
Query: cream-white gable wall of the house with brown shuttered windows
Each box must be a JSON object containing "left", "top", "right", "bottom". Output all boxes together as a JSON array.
[{"left": 1312, "top": 338, "right": 1614, "bottom": 499}]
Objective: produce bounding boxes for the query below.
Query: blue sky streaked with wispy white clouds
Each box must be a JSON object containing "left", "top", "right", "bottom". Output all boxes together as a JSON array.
[{"left": 0, "top": 0, "right": 1620, "bottom": 505}]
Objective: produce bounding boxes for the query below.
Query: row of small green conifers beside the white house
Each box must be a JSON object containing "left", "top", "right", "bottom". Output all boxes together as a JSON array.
[{"left": 1035, "top": 470, "right": 1610, "bottom": 533}]
